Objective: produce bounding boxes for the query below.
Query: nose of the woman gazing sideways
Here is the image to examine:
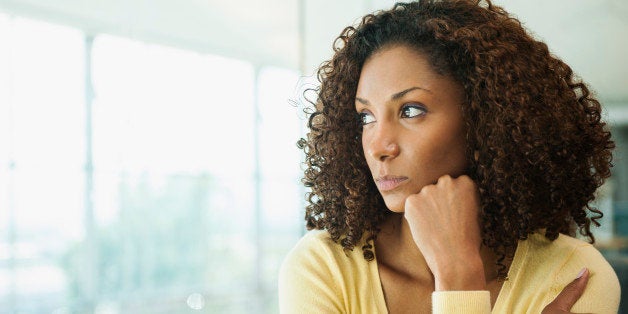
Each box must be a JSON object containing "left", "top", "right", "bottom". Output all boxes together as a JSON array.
[{"left": 362, "top": 123, "right": 400, "bottom": 161}]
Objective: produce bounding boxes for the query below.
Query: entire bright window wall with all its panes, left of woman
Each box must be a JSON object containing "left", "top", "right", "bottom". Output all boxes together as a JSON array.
[{"left": 0, "top": 15, "right": 303, "bottom": 313}]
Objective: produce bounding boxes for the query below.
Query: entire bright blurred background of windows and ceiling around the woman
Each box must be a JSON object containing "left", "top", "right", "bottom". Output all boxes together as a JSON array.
[{"left": 0, "top": 0, "right": 628, "bottom": 314}]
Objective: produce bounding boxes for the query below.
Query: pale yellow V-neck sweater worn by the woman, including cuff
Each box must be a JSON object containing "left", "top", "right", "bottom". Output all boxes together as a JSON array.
[{"left": 279, "top": 230, "right": 620, "bottom": 313}]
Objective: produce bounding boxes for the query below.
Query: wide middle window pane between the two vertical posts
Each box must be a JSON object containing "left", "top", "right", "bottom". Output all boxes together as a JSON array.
[{"left": 86, "top": 36, "right": 256, "bottom": 313}]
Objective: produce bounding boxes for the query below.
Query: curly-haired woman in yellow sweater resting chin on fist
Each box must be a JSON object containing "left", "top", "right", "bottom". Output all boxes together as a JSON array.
[{"left": 279, "top": 1, "right": 619, "bottom": 313}]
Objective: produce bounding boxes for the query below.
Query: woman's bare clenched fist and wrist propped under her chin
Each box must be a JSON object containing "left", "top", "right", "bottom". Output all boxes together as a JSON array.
[{"left": 404, "top": 175, "right": 486, "bottom": 291}]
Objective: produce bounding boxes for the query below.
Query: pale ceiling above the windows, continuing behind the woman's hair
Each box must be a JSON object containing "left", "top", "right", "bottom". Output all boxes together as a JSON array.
[{"left": 0, "top": 0, "right": 628, "bottom": 106}]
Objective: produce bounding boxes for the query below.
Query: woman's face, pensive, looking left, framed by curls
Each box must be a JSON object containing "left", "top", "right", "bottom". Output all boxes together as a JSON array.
[{"left": 355, "top": 46, "right": 467, "bottom": 212}]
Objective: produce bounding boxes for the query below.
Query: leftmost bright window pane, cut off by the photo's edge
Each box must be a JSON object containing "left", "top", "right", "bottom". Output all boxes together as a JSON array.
[{"left": 0, "top": 17, "right": 85, "bottom": 313}]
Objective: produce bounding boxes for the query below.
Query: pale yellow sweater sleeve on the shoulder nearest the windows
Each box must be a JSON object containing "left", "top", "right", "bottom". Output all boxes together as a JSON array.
[{"left": 278, "top": 235, "right": 343, "bottom": 314}]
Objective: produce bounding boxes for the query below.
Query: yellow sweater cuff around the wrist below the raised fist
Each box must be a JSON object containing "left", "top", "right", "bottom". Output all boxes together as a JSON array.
[{"left": 432, "top": 290, "right": 491, "bottom": 314}]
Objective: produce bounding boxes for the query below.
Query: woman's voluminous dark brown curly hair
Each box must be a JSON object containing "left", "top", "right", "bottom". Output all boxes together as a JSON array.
[{"left": 298, "top": 0, "right": 614, "bottom": 276}]
